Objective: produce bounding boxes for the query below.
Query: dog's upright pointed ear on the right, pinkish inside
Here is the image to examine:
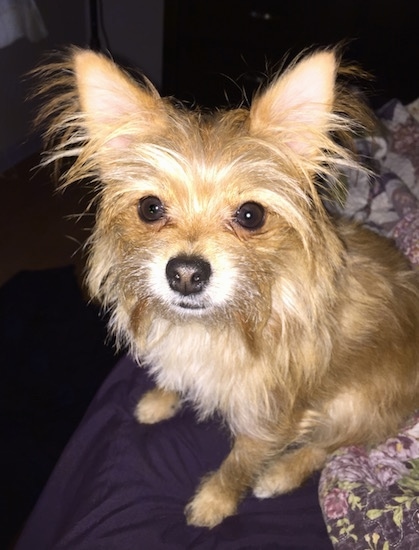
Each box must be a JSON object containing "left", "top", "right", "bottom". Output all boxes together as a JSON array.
[{"left": 250, "top": 51, "right": 337, "bottom": 155}]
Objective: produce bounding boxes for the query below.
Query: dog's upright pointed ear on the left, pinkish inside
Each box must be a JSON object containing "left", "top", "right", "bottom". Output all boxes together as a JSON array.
[{"left": 73, "top": 50, "right": 165, "bottom": 148}]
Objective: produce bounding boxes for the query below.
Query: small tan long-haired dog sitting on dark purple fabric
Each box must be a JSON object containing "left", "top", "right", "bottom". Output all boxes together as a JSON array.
[{"left": 37, "top": 49, "right": 419, "bottom": 528}]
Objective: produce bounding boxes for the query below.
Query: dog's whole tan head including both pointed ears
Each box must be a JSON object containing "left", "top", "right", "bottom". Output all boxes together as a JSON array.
[{"left": 43, "top": 52, "right": 354, "bottom": 348}]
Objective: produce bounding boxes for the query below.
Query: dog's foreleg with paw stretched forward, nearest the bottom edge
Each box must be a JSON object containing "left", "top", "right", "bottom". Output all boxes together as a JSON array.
[{"left": 185, "top": 435, "right": 271, "bottom": 528}]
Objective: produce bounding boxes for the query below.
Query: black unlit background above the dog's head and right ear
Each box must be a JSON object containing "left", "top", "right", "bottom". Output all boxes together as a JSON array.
[{"left": 163, "top": 0, "right": 419, "bottom": 106}]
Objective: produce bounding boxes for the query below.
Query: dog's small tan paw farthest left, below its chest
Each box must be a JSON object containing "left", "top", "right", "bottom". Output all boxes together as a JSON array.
[{"left": 135, "top": 388, "right": 180, "bottom": 424}]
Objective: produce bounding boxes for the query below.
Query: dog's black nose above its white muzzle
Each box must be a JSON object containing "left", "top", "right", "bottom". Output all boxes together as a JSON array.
[{"left": 166, "top": 256, "right": 211, "bottom": 296}]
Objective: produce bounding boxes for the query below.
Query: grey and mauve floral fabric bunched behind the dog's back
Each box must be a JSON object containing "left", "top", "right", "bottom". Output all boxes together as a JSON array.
[{"left": 336, "top": 100, "right": 419, "bottom": 266}]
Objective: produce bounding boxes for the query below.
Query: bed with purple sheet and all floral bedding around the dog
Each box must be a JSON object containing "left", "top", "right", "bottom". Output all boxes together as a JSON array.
[{"left": 16, "top": 96, "right": 419, "bottom": 550}]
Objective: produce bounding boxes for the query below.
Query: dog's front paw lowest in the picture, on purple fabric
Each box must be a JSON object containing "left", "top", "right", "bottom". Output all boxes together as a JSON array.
[{"left": 185, "top": 474, "right": 237, "bottom": 529}]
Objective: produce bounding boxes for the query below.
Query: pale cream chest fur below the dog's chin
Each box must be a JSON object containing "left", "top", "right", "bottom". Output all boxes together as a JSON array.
[{"left": 139, "top": 322, "right": 264, "bottom": 433}]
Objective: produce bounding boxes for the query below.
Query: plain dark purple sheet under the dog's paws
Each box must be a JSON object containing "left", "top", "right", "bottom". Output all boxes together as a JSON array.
[{"left": 15, "top": 357, "right": 332, "bottom": 550}]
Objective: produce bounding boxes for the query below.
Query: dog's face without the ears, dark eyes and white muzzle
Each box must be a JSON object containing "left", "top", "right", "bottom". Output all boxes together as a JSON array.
[{"left": 91, "top": 118, "right": 308, "bottom": 340}]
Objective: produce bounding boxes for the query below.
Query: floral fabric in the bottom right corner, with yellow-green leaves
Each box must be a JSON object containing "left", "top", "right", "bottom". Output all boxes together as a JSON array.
[{"left": 319, "top": 413, "right": 419, "bottom": 550}]
